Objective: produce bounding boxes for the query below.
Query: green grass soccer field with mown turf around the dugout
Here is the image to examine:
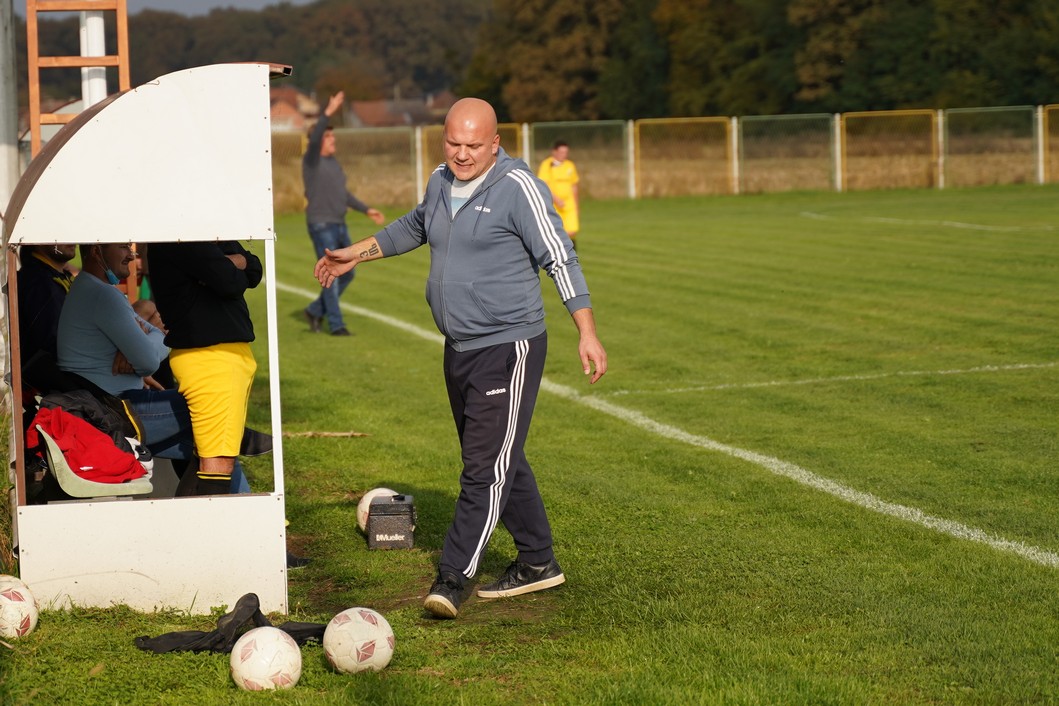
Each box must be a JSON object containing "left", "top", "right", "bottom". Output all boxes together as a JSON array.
[{"left": 0, "top": 186, "right": 1059, "bottom": 704}]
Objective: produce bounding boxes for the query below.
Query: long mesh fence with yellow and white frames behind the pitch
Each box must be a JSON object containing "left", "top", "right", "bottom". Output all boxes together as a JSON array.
[{"left": 272, "top": 105, "right": 1059, "bottom": 212}]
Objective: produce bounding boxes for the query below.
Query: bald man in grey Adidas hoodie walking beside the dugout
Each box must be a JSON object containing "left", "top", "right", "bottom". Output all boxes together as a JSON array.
[{"left": 316, "top": 98, "right": 607, "bottom": 618}]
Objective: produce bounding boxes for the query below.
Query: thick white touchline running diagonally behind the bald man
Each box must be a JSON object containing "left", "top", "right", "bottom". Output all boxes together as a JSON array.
[{"left": 276, "top": 282, "right": 1059, "bottom": 568}]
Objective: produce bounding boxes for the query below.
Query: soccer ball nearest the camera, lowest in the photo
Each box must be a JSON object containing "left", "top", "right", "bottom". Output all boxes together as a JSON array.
[{"left": 229, "top": 626, "right": 302, "bottom": 691}]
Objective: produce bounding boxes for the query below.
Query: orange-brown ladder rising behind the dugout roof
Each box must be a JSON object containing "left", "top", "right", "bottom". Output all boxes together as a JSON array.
[{"left": 25, "top": 0, "right": 130, "bottom": 157}]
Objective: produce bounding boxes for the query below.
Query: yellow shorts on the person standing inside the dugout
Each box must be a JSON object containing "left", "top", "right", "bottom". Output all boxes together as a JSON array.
[{"left": 169, "top": 343, "right": 257, "bottom": 458}]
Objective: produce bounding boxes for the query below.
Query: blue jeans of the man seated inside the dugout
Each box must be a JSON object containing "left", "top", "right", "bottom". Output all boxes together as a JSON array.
[{"left": 121, "top": 390, "right": 250, "bottom": 493}]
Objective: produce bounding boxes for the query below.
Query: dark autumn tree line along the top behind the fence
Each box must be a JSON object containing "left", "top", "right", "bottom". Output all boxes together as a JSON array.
[{"left": 10, "top": 0, "right": 1059, "bottom": 122}]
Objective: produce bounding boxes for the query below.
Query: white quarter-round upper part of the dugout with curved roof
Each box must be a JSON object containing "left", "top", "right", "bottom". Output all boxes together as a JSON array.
[{"left": 3, "top": 64, "right": 290, "bottom": 246}]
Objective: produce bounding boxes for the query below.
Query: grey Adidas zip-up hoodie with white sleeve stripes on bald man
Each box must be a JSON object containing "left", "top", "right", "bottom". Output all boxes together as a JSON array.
[{"left": 375, "top": 148, "right": 592, "bottom": 350}]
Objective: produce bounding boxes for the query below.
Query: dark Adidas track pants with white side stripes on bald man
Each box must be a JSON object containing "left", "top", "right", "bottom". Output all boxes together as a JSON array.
[{"left": 439, "top": 333, "right": 554, "bottom": 578}]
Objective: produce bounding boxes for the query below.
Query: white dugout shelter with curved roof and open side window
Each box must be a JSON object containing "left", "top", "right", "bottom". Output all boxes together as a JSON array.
[{"left": 3, "top": 64, "right": 290, "bottom": 614}]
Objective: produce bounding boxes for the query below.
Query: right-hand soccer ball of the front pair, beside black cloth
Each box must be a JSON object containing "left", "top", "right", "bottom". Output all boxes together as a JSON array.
[{"left": 324, "top": 608, "right": 395, "bottom": 674}]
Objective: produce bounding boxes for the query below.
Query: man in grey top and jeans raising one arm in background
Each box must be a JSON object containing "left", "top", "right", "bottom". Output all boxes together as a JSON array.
[{"left": 302, "top": 91, "right": 384, "bottom": 336}]
